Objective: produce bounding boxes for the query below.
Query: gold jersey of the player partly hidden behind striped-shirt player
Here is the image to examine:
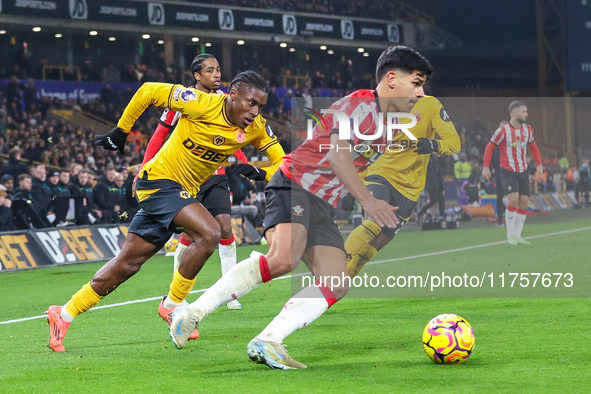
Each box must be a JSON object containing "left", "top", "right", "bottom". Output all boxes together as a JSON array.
[{"left": 363, "top": 96, "right": 461, "bottom": 201}]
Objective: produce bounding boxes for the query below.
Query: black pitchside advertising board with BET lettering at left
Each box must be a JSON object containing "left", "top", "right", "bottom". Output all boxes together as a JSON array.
[{"left": 0, "top": 225, "right": 128, "bottom": 271}]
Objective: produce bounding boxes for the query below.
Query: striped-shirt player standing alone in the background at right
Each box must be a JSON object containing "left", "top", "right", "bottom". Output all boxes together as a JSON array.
[{"left": 482, "top": 101, "right": 543, "bottom": 245}]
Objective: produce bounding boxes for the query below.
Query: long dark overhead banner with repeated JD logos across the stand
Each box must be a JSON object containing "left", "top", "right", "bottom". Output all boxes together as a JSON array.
[{"left": 0, "top": 0, "right": 404, "bottom": 44}]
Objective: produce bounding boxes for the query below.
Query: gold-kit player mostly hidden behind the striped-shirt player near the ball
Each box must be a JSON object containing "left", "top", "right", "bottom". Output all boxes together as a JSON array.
[{"left": 345, "top": 96, "right": 461, "bottom": 277}]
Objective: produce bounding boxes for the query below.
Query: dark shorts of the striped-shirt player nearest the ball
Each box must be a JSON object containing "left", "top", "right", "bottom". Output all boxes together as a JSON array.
[{"left": 264, "top": 170, "right": 345, "bottom": 251}]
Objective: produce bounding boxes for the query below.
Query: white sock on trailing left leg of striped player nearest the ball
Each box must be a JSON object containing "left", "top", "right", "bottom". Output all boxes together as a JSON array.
[{"left": 188, "top": 256, "right": 263, "bottom": 319}]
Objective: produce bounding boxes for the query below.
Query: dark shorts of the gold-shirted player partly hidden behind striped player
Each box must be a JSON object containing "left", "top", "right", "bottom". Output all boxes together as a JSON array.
[{"left": 363, "top": 175, "right": 418, "bottom": 239}]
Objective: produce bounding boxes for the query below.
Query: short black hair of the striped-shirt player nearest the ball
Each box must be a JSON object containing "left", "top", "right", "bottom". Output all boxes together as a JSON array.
[{"left": 376, "top": 45, "right": 433, "bottom": 83}]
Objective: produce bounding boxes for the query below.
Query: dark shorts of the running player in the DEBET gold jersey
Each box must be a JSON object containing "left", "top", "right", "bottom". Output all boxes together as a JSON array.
[{"left": 129, "top": 178, "right": 199, "bottom": 249}]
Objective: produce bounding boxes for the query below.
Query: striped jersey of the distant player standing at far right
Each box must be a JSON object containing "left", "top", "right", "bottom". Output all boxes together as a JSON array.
[{"left": 490, "top": 123, "right": 534, "bottom": 172}]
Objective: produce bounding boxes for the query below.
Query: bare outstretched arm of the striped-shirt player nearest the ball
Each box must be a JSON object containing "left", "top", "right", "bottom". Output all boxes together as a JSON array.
[{"left": 328, "top": 134, "right": 399, "bottom": 228}]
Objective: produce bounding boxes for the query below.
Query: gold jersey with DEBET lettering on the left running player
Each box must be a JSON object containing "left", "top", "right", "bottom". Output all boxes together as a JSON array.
[{"left": 117, "top": 83, "right": 285, "bottom": 200}]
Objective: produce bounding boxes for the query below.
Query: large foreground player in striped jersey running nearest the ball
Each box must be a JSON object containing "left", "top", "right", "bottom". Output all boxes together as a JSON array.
[{"left": 170, "top": 46, "right": 440, "bottom": 369}]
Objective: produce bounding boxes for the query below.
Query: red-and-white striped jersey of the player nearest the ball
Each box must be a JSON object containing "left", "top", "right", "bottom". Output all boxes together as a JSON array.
[{"left": 280, "top": 89, "right": 387, "bottom": 207}]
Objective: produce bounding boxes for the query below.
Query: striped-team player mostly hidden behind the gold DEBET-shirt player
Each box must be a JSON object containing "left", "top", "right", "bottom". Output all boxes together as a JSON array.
[{"left": 137, "top": 53, "right": 248, "bottom": 314}]
